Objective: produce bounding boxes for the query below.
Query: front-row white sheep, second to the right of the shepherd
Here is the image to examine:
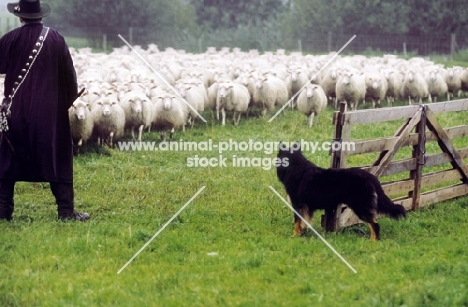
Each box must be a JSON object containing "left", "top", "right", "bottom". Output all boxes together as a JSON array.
[{"left": 91, "top": 96, "right": 125, "bottom": 147}]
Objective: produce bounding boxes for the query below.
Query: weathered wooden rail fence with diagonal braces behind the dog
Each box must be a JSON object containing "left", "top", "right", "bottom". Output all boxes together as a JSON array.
[{"left": 322, "top": 99, "right": 468, "bottom": 231}]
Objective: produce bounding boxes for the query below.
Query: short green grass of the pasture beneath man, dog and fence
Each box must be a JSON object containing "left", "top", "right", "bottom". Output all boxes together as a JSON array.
[{"left": 0, "top": 100, "right": 468, "bottom": 306}]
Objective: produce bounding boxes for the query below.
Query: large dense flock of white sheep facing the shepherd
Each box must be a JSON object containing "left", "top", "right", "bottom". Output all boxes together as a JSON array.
[{"left": 5, "top": 44, "right": 468, "bottom": 146}]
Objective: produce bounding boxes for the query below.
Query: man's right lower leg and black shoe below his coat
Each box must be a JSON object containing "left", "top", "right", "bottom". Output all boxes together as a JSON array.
[{"left": 50, "top": 182, "right": 89, "bottom": 221}]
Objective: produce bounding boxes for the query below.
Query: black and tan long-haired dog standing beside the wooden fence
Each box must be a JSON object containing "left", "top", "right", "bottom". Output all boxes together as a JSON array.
[{"left": 276, "top": 143, "right": 406, "bottom": 240}]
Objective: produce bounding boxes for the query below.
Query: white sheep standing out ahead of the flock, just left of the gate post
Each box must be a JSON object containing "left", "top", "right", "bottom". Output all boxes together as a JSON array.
[{"left": 297, "top": 84, "right": 327, "bottom": 127}]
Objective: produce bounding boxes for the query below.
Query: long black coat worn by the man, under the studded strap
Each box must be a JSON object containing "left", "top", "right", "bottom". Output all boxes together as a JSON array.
[{"left": 0, "top": 23, "right": 77, "bottom": 183}]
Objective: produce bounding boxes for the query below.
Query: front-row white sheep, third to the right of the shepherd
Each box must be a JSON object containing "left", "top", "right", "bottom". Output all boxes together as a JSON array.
[{"left": 120, "top": 91, "right": 153, "bottom": 142}]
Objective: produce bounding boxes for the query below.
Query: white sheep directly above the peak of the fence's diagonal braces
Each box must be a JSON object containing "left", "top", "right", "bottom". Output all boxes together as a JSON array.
[{"left": 401, "top": 68, "right": 432, "bottom": 104}]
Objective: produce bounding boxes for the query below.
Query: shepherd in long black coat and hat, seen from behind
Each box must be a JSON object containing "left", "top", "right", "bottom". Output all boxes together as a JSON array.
[{"left": 0, "top": 0, "right": 89, "bottom": 221}]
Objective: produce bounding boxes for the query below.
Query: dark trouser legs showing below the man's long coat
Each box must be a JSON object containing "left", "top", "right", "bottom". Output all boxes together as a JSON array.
[{"left": 0, "top": 180, "right": 75, "bottom": 220}]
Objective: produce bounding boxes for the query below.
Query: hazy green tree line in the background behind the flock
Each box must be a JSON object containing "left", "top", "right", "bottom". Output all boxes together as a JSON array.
[{"left": 42, "top": 0, "right": 468, "bottom": 50}]
